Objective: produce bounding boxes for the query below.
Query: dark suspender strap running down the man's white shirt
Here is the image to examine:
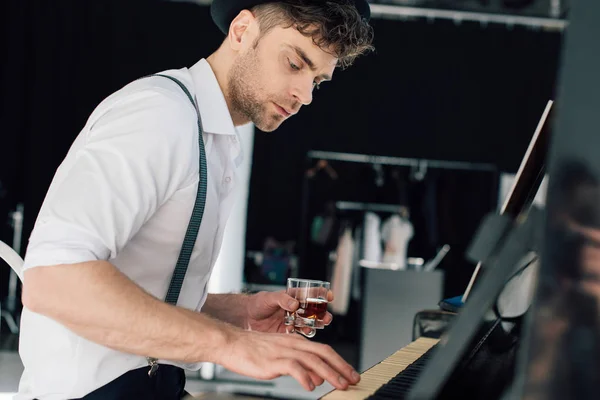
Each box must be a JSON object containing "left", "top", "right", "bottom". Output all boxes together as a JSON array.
[{"left": 146, "top": 74, "right": 207, "bottom": 376}]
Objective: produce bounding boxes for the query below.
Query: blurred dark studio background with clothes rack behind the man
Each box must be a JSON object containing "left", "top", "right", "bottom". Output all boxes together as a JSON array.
[{"left": 0, "top": 0, "right": 569, "bottom": 399}]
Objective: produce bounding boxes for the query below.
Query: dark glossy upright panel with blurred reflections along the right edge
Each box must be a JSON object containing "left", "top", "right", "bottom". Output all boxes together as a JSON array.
[{"left": 511, "top": 0, "right": 600, "bottom": 400}]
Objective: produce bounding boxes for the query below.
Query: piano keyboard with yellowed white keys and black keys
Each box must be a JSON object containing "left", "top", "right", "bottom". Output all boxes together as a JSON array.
[{"left": 321, "top": 337, "right": 439, "bottom": 400}]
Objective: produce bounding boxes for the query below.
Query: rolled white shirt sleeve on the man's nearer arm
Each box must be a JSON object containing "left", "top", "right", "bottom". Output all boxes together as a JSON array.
[{"left": 24, "top": 89, "right": 197, "bottom": 269}]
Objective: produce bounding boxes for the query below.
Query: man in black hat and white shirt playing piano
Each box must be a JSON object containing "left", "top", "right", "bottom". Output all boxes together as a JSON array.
[{"left": 17, "top": 0, "right": 372, "bottom": 400}]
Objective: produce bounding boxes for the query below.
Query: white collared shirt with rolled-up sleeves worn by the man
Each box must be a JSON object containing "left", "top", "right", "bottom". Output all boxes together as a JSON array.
[{"left": 16, "top": 59, "right": 242, "bottom": 400}]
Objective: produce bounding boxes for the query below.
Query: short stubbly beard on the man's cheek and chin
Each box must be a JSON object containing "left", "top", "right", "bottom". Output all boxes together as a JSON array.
[{"left": 228, "top": 48, "right": 284, "bottom": 132}]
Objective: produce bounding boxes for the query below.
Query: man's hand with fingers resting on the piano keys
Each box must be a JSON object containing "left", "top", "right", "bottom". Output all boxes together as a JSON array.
[{"left": 217, "top": 329, "right": 360, "bottom": 391}]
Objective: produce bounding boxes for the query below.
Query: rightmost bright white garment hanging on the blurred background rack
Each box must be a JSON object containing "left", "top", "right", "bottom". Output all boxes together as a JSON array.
[{"left": 381, "top": 215, "right": 414, "bottom": 269}]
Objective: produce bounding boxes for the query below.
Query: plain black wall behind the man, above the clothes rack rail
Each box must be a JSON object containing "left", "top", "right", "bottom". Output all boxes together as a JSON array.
[{"left": 0, "top": 0, "right": 561, "bottom": 295}]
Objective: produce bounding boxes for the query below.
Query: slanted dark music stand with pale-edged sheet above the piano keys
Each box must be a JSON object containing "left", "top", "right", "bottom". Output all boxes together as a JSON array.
[{"left": 407, "top": 101, "right": 552, "bottom": 400}]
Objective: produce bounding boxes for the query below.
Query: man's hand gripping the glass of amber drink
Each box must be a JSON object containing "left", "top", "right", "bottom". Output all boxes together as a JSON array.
[{"left": 245, "top": 291, "right": 333, "bottom": 335}]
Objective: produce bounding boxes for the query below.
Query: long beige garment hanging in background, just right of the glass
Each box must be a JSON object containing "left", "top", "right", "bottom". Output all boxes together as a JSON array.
[{"left": 329, "top": 227, "right": 354, "bottom": 315}]
